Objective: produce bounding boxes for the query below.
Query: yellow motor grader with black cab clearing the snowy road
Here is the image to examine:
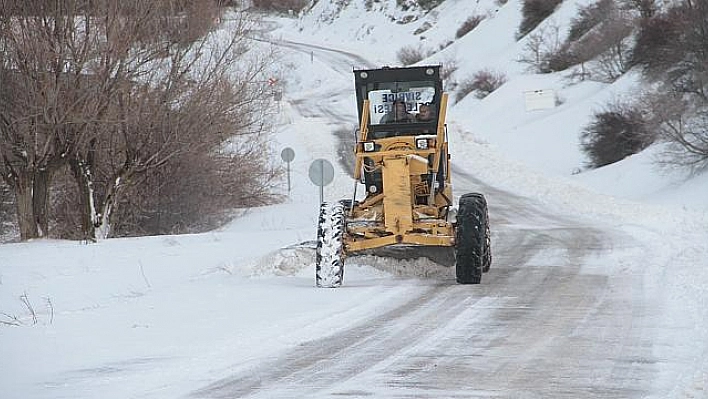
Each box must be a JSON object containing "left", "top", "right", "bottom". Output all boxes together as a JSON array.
[{"left": 316, "top": 65, "right": 491, "bottom": 288}]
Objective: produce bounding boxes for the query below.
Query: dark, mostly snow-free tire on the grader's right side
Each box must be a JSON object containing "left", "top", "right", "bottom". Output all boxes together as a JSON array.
[{"left": 455, "top": 193, "right": 491, "bottom": 284}]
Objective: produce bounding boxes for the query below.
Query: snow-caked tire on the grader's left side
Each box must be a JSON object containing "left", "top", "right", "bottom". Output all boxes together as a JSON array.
[{"left": 315, "top": 202, "right": 345, "bottom": 288}]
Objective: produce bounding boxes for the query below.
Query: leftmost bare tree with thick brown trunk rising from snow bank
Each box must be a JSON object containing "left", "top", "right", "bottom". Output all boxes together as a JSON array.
[{"left": 0, "top": 2, "right": 103, "bottom": 239}]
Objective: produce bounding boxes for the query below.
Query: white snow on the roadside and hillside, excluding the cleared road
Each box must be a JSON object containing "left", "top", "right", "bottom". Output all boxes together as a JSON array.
[{"left": 0, "top": 0, "right": 708, "bottom": 399}]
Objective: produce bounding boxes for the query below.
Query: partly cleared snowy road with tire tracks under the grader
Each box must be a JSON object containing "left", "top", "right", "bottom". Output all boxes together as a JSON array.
[{"left": 195, "top": 35, "right": 668, "bottom": 398}]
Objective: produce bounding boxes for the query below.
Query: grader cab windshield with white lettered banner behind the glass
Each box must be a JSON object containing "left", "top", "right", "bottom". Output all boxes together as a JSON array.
[{"left": 367, "top": 82, "right": 437, "bottom": 125}]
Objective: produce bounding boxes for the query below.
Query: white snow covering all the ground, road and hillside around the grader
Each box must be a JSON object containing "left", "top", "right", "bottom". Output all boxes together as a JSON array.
[{"left": 0, "top": 0, "right": 708, "bottom": 399}]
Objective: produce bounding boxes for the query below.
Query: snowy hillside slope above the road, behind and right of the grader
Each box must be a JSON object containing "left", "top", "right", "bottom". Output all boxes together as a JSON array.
[{"left": 292, "top": 0, "right": 708, "bottom": 210}]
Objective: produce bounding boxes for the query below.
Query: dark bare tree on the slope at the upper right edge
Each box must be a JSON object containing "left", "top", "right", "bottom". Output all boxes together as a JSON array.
[{"left": 632, "top": 0, "right": 708, "bottom": 169}]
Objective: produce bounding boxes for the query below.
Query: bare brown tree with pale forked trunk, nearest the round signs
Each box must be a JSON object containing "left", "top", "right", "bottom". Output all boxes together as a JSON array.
[{"left": 95, "top": 45, "right": 277, "bottom": 241}]
